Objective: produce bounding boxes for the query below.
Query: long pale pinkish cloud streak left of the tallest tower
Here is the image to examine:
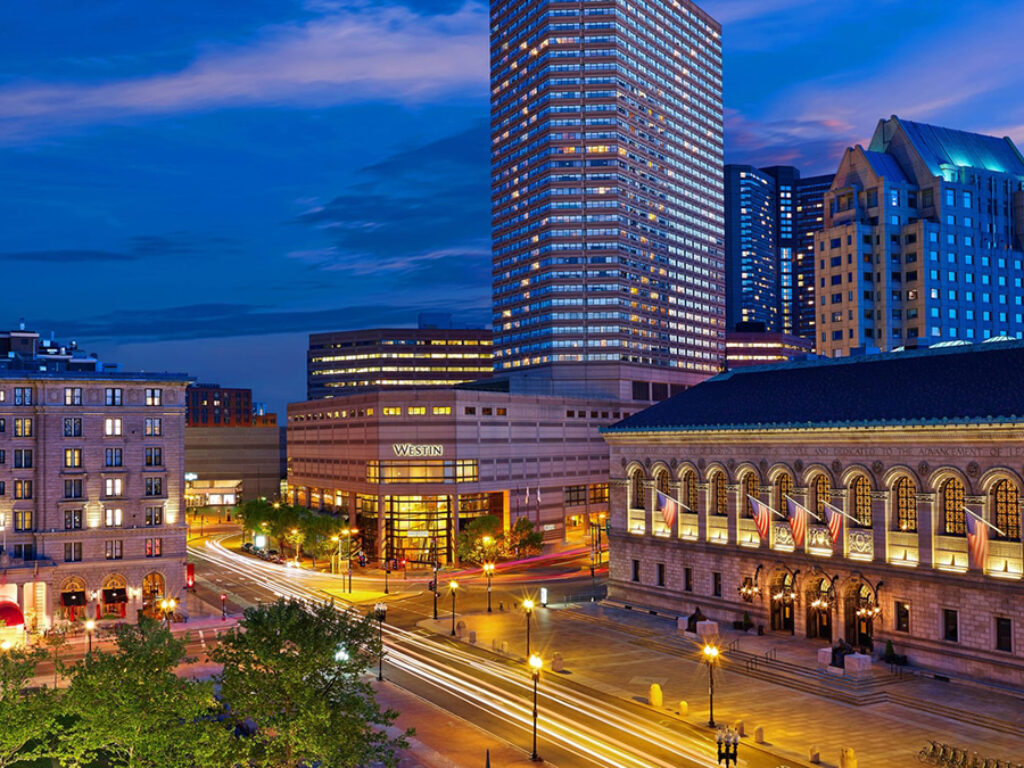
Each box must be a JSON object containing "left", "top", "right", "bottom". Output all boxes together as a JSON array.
[{"left": 0, "top": 4, "right": 487, "bottom": 142}]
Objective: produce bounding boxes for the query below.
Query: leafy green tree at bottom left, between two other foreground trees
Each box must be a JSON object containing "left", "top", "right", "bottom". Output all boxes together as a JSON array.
[{"left": 50, "top": 618, "right": 237, "bottom": 768}]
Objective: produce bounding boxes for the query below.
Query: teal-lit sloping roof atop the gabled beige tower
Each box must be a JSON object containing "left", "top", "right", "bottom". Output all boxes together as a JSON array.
[{"left": 868, "top": 115, "right": 1024, "bottom": 177}]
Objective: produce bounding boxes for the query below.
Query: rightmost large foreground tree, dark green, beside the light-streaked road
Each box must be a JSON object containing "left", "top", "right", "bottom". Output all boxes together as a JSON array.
[{"left": 211, "top": 600, "right": 412, "bottom": 768}]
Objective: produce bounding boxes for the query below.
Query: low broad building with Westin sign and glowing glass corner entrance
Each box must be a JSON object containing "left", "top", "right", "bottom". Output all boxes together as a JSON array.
[{"left": 280, "top": 384, "right": 635, "bottom": 566}]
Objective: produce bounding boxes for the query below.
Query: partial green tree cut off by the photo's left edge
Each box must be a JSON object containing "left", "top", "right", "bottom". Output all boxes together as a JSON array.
[{"left": 0, "top": 648, "right": 58, "bottom": 768}]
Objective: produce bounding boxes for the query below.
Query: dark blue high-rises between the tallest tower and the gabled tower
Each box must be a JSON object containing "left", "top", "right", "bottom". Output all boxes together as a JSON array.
[{"left": 725, "top": 165, "right": 833, "bottom": 341}]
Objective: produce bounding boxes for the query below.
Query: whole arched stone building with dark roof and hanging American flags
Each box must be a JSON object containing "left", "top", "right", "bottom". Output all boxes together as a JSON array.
[{"left": 604, "top": 340, "right": 1024, "bottom": 686}]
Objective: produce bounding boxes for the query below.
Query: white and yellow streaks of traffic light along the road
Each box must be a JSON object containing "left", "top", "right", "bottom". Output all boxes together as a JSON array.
[{"left": 188, "top": 540, "right": 720, "bottom": 768}]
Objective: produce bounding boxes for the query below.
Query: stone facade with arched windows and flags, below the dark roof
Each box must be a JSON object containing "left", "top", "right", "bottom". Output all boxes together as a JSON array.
[{"left": 606, "top": 423, "right": 1024, "bottom": 685}]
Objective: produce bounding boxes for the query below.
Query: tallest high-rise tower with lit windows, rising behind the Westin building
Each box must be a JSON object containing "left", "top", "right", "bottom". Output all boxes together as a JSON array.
[{"left": 490, "top": 0, "right": 725, "bottom": 399}]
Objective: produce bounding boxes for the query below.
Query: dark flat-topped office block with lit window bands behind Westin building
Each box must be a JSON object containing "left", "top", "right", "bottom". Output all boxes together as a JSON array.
[{"left": 306, "top": 316, "right": 494, "bottom": 399}]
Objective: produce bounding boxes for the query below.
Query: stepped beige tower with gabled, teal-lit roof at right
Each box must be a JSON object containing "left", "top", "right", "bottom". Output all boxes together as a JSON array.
[{"left": 815, "top": 116, "right": 1024, "bottom": 356}]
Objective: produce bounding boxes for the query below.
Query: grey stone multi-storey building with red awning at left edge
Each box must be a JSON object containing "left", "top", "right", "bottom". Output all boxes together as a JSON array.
[{"left": 0, "top": 331, "right": 189, "bottom": 640}]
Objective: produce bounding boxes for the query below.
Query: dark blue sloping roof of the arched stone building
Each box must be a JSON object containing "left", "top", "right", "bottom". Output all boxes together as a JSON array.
[{"left": 602, "top": 339, "right": 1024, "bottom": 433}]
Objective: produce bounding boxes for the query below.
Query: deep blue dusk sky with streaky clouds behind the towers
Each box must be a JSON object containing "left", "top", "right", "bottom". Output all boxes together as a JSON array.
[{"left": 0, "top": 0, "right": 1024, "bottom": 409}]
